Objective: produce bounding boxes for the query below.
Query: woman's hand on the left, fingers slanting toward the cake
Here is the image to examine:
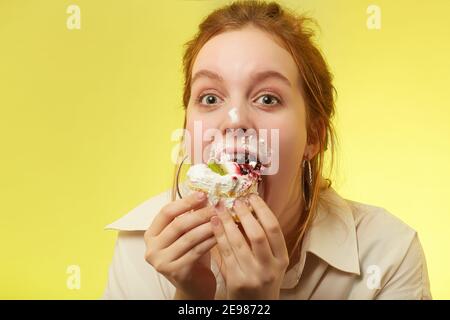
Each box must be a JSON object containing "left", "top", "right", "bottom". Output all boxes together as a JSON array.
[{"left": 144, "top": 192, "right": 216, "bottom": 299}]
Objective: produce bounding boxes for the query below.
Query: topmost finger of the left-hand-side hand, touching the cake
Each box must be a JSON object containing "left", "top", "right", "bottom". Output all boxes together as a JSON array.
[{"left": 148, "top": 192, "right": 206, "bottom": 237}]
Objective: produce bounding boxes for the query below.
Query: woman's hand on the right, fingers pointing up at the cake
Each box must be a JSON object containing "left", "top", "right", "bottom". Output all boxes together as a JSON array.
[{"left": 211, "top": 194, "right": 289, "bottom": 299}]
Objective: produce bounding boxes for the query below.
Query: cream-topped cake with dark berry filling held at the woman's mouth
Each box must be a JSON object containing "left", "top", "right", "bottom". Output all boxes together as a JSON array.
[{"left": 187, "top": 136, "right": 270, "bottom": 222}]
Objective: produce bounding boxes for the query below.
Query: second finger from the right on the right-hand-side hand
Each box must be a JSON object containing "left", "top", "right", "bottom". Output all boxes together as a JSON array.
[{"left": 233, "top": 200, "right": 273, "bottom": 261}]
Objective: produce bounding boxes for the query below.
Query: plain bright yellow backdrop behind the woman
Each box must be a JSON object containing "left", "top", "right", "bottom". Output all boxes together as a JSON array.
[{"left": 0, "top": 0, "right": 450, "bottom": 299}]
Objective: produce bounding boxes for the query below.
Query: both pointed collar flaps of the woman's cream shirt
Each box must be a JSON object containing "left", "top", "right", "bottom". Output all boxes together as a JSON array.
[{"left": 105, "top": 181, "right": 360, "bottom": 289}]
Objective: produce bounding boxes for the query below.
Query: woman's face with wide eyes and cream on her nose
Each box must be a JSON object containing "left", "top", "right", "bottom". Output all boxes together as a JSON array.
[{"left": 186, "top": 26, "right": 309, "bottom": 215}]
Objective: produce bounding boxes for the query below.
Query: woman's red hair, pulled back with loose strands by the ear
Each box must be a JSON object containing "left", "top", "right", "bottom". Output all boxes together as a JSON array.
[{"left": 172, "top": 1, "right": 336, "bottom": 262}]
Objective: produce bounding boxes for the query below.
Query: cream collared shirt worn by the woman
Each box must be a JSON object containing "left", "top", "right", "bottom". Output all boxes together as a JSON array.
[{"left": 103, "top": 187, "right": 431, "bottom": 299}]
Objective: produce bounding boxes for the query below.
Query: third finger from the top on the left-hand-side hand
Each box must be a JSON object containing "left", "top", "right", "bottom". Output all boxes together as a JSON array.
[{"left": 162, "top": 221, "right": 214, "bottom": 261}]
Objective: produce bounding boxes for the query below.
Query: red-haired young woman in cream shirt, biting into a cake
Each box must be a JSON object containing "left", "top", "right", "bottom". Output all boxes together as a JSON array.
[{"left": 104, "top": 1, "right": 431, "bottom": 299}]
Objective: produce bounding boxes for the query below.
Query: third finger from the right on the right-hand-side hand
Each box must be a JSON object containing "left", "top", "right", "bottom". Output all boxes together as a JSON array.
[{"left": 216, "top": 203, "right": 255, "bottom": 271}]
